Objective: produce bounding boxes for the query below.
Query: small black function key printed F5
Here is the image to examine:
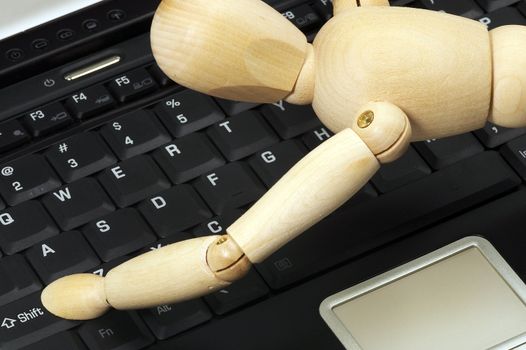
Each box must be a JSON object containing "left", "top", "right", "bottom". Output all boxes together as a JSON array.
[{"left": 108, "top": 68, "right": 159, "bottom": 102}]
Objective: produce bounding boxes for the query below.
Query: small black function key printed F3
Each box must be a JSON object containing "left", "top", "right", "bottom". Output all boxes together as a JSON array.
[{"left": 22, "top": 102, "right": 73, "bottom": 137}]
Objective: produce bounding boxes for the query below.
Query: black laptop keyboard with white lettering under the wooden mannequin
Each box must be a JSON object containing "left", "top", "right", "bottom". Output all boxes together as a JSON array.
[{"left": 0, "top": 0, "right": 526, "bottom": 350}]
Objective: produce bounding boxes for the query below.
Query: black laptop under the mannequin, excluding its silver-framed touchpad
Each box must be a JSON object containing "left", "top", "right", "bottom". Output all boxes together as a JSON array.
[{"left": 0, "top": 0, "right": 526, "bottom": 350}]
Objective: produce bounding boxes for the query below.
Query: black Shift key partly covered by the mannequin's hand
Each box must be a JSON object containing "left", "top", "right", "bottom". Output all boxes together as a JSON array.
[{"left": 0, "top": 292, "right": 78, "bottom": 350}]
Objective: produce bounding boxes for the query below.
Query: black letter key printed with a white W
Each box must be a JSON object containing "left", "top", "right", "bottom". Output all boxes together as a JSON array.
[{"left": 42, "top": 177, "right": 115, "bottom": 231}]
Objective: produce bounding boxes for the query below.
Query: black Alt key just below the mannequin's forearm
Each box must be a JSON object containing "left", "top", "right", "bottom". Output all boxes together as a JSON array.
[{"left": 140, "top": 299, "right": 212, "bottom": 339}]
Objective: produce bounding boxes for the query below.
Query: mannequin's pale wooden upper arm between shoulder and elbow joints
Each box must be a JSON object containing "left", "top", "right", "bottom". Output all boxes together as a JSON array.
[{"left": 227, "top": 129, "right": 379, "bottom": 263}]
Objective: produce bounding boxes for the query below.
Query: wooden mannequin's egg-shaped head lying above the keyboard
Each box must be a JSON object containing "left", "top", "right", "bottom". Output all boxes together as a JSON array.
[{"left": 151, "top": 0, "right": 308, "bottom": 102}]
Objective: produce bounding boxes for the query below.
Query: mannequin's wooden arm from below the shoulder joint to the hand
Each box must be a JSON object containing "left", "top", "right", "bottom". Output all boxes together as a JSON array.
[{"left": 42, "top": 129, "right": 388, "bottom": 320}]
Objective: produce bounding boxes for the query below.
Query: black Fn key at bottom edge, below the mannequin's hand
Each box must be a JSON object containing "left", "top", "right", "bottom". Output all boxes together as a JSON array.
[{"left": 79, "top": 311, "right": 154, "bottom": 350}]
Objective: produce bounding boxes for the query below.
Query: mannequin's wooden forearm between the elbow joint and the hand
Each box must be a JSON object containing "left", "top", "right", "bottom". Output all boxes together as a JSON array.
[{"left": 105, "top": 236, "right": 230, "bottom": 310}]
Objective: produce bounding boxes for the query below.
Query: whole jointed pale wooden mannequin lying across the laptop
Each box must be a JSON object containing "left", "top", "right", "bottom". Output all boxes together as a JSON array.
[{"left": 42, "top": 0, "right": 526, "bottom": 320}]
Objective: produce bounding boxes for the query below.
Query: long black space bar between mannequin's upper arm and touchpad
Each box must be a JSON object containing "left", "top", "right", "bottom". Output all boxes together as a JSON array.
[{"left": 256, "top": 151, "right": 520, "bottom": 289}]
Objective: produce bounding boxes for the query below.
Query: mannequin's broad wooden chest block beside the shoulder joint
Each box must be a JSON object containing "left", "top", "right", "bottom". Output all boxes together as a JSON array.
[{"left": 313, "top": 6, "right": 492, "bottom": 141}]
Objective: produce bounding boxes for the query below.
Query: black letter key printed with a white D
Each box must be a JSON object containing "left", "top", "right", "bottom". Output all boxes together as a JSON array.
[{"left": 138, "top": 185, "right": 217, "bottom": 237}]
